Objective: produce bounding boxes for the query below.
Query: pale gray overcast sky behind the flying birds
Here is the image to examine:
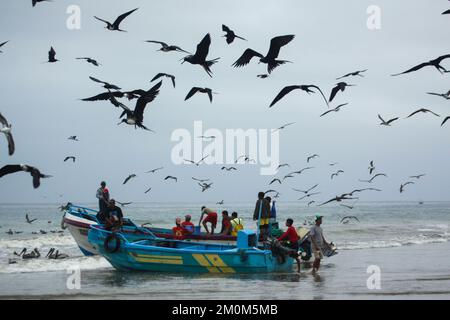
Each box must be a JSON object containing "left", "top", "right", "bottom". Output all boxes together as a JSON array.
[{"left": 0, "top": 0, "right": 450, "bottom": 203}]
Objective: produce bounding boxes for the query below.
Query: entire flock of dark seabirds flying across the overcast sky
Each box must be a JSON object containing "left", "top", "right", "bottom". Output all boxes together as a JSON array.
[{"left": 0, "top": 0, "right": 450, "bottom": 220}]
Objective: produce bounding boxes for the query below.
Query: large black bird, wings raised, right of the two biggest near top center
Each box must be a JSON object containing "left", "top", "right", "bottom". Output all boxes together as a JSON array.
[{"left": 232, "top": 35, "right": 295, "bottom": 74}]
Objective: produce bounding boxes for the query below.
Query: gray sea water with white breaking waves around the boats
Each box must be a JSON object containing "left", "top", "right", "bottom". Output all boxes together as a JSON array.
[{"left": 0, "top": 202, "right": 450, "bottom": 299}]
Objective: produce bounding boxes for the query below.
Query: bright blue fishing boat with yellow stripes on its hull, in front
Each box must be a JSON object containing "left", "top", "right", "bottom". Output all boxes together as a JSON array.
[{"left": 88, "top": 225, "right": 293, "bottom": 273}]
